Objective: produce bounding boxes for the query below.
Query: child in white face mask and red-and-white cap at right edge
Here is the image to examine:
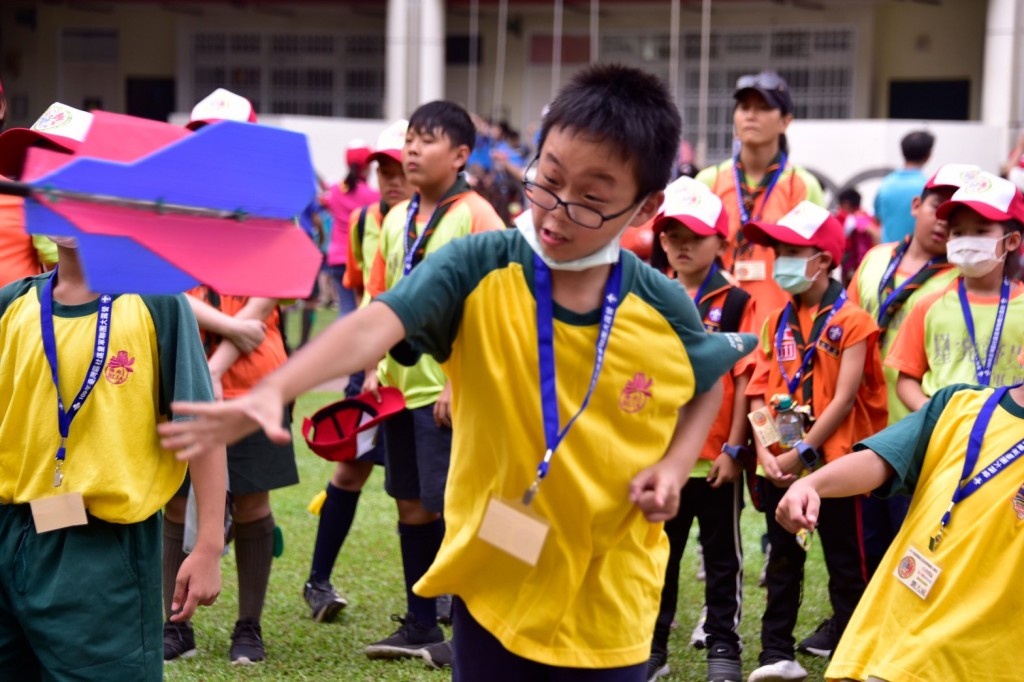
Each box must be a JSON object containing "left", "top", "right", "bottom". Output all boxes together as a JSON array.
[{"left": 886, "top": 173, "right": 1024, "bottom": 410}]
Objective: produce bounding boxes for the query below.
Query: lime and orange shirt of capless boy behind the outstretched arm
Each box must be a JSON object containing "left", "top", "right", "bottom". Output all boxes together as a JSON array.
[{"left": 367, "top": 190, "right": 505, "bottom": 410}]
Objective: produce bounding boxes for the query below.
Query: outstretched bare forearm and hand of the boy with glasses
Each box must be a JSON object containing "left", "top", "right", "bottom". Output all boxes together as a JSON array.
[{"left": 159, "top": 302, "right": 406, "bottom": 457}]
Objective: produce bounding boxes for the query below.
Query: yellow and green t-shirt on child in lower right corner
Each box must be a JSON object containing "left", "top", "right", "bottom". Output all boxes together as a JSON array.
[{"left": 826, "top": 385, "right": 1024, "bottom": 682}]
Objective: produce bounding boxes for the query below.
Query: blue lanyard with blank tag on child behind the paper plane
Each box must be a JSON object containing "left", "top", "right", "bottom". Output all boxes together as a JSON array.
[{"left": 29, "top": 269, "right": 113, "bottom": 532}]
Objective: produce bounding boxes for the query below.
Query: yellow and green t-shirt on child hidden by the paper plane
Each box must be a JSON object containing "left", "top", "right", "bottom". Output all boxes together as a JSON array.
[{"left": 0, "top": 273, "right": 213, "bottom": 523}]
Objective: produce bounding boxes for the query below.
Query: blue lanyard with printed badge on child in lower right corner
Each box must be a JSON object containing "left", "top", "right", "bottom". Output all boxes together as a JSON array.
[{"left": 893, "top": 386, "right": 1024, "bottom": 599}]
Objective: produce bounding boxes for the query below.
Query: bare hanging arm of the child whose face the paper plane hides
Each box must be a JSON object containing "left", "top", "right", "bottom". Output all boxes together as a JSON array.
[{"left": 171, "top": 440, "right": 227, "bottom": 622}]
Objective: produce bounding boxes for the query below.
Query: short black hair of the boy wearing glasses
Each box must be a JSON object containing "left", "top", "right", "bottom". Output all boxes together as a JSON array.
[{"left": 538, "top": 63, "right": 682, "bottom": 199}]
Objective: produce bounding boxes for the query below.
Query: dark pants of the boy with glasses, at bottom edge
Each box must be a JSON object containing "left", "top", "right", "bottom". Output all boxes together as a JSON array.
[{"left": 452, "top": 597, "right": 647, "bottom": 682}]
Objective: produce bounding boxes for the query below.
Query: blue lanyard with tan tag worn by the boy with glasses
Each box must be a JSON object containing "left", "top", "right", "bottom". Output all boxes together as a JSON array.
[{"left": 477, "top": 256, "right": 623, "bottom": 566}]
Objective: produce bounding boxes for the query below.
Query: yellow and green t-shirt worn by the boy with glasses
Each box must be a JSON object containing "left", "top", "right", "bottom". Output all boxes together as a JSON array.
[{"left": 379, "top": 230, "right": 756, "bottom": 668}]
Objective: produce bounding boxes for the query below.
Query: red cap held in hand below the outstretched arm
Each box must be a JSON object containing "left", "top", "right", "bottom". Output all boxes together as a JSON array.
[{"left": 302, "top": 386, "right": 406, "bottom": 462}]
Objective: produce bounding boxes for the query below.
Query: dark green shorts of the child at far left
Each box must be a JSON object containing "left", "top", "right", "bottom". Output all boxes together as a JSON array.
[{"left": 0, "top": 505, "right": 164, "bottom": 681}]
